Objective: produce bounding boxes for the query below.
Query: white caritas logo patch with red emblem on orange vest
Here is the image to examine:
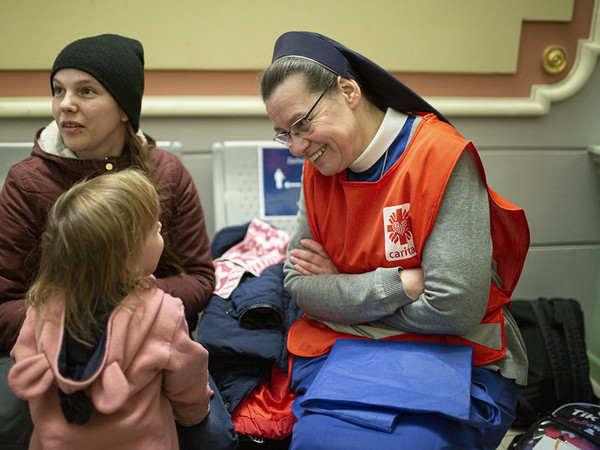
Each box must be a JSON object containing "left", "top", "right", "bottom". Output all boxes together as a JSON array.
[{"left": 383, "top": 203, "right": 417, "bottom": 261}]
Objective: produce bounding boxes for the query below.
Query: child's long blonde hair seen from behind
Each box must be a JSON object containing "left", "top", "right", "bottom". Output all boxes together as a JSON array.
[{"left": 27, "top": 169, "right": 160, "bottom": 344}]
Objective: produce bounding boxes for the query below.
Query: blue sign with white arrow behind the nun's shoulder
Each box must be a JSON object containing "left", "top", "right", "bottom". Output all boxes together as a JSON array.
[{"left": 259, "top": 147, "right": 304, "bottom": 218}]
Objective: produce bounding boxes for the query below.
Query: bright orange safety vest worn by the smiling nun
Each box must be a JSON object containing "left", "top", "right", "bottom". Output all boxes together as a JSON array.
[{"left": 288, "top": 114, "right": 529, "bottom": 365}]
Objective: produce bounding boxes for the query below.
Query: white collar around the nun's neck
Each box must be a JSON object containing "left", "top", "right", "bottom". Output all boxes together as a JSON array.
[{"left": 348, "top": 108, "right": 408, "bottom": 173}]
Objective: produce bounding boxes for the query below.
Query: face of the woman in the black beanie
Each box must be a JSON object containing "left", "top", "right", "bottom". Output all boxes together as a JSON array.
[{"left": 52, "top": 69, "right": 128, "bottom": 159}]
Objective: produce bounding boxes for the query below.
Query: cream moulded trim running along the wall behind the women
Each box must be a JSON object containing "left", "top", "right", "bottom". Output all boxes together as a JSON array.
[{"left": 0, "top": 1, "right": 600, "bottom": 118}]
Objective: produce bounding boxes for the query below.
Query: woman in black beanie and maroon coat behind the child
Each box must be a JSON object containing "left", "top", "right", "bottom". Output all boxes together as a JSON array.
[{"left": 0, "top": 34, "right": 236, "bottom": 448}]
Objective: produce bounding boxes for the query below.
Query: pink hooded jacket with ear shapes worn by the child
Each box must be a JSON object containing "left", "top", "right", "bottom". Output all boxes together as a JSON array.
[{"left": 9, "top": 288, "right": 211, "bottom": 450}]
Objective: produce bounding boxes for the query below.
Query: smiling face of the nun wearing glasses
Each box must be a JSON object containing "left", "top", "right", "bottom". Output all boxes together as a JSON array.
[{"left": 265, "top": 76, "right": 372, "bottom": 175}]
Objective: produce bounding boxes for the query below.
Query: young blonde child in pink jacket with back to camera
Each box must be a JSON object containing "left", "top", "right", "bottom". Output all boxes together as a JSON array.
[{"left": 9, "top": 169, "right": 212, "bottom": 450}]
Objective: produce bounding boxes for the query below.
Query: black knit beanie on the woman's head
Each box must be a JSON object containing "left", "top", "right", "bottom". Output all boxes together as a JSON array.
[{"left": 50, "top": 34, "right": 144, "bottom": 132}]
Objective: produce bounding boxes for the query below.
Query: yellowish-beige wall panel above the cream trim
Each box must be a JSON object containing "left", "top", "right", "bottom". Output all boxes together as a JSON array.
[{"left": 0, "top": 0, "right": 573, "bottom": 73}]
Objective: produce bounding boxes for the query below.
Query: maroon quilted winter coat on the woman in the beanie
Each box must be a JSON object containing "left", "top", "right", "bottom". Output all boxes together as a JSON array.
[{"left": 0, "top": 125, "right": 215, "bottom": 352}]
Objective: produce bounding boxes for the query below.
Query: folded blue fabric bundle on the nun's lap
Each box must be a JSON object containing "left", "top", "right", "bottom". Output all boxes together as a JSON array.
[{"left": 301, "top": 339, "right": 473, "bottom": 432}]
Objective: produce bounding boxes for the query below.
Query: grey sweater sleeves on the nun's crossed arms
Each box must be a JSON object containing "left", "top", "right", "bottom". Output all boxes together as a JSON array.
[{"left": 284, "top": 152, "right": 492, "bottom": 335}]
